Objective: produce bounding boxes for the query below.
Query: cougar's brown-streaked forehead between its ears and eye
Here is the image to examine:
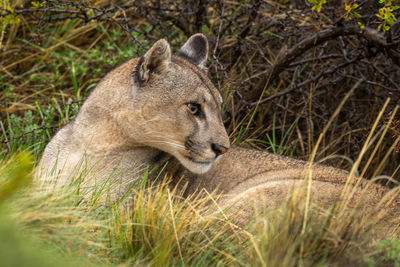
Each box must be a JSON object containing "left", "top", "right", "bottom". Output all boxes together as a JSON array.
[{"left": 172, "top": 57, "right": 223, "bottom": 107}]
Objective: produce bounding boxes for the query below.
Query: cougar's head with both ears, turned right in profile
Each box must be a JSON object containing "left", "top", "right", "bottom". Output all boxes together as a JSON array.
[{"left": 132, "top": 34, "right": 229, "bottom": 174}]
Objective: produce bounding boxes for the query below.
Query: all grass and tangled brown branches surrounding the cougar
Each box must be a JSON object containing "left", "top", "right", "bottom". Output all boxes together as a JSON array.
[{"left": 0, "top": 0, "right": 400, "bottom": 266}]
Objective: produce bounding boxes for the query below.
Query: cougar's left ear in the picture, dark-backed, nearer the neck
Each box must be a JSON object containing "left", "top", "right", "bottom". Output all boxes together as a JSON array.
[{"left": 135, "top": 39, "right": 171, "bottom": 83}]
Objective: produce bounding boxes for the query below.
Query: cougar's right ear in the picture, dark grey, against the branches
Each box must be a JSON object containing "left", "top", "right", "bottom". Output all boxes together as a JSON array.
[{"left": 176, "top": 33, "right": 208, "bottom": 70}]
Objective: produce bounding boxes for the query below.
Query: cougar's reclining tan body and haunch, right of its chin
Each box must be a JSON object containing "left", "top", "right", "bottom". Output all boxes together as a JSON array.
[{"left": 179, "top": 147, "right": 400, "bottom": 229}]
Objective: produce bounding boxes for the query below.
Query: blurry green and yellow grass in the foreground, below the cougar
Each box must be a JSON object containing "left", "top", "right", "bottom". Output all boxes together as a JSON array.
[{"left": 0, "top": 153, "right": 399, "bottom": 266}]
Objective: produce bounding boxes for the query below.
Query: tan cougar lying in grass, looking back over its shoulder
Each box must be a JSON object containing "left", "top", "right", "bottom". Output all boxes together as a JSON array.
[{"left": 37, "top": 34, "right": 399, "bottom": 228}]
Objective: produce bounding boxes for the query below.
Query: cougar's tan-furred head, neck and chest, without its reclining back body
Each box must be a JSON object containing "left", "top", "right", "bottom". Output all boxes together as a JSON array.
[{"left": 37, "top": 35, "right": 229, "bottom": 195}]
